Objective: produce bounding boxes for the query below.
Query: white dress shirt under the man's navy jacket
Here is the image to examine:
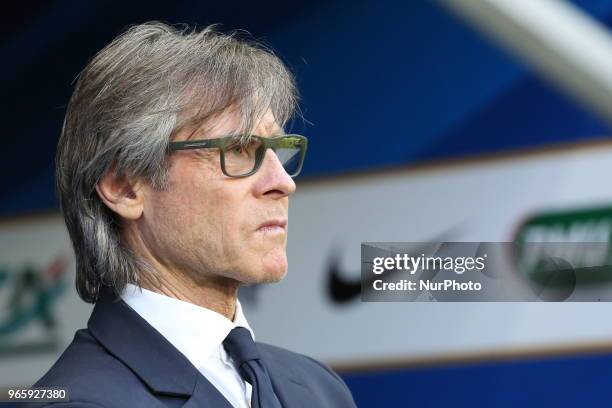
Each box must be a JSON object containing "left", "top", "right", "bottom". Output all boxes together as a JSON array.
[{"left": 121, "top": 284, "right": 255, "bottom": 408}]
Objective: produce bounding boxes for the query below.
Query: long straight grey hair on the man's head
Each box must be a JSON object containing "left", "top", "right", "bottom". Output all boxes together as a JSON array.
[{"left": 56, "top": 22, "right": 298, "bottom": 303}]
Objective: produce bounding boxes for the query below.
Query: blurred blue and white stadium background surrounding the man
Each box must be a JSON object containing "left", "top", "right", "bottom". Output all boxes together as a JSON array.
[{"left": 0, "top": 0, "right": 612, "bottom": 408}]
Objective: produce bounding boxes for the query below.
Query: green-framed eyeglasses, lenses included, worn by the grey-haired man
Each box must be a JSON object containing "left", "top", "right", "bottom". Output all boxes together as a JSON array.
[{"left": 170, "top": 135, "right": 308, "bottom": 177}]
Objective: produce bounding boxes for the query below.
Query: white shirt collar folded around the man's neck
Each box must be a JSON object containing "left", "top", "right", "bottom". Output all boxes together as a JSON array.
[{"left": 121, "top": 284, "right": 255, "bottom": 367}]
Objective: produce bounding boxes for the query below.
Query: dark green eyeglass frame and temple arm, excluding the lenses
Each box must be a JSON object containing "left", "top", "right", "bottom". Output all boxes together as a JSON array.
[{"left": 169, "top": 135, "right": 308, "bottom": 178}]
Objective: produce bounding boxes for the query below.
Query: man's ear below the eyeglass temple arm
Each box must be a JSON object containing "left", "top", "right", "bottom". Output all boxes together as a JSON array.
[{"left": 96, "top": 166, "right": 144, "bottom": 220}]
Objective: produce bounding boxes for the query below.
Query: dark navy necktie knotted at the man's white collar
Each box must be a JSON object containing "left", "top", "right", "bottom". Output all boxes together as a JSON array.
[{"left": 223, "top": 327, "right": 281, "bottom": 408}]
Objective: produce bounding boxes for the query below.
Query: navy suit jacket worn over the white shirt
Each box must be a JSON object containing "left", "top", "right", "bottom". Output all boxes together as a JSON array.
[{"left": 32, "top": 291, "right": 355, "bottom": 408}]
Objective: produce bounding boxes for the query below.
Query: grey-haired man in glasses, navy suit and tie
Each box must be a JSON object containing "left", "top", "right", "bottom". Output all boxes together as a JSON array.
[{"left": 28, "top": 23, "right": 354, "bottom": 408}]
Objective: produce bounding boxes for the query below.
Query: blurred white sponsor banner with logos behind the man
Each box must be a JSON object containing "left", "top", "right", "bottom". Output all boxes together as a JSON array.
[{"left": 0, "top": 141, "right": 612, "bottom": 386}]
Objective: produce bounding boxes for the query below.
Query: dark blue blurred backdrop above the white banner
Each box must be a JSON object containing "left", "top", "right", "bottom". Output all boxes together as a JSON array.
[{"left": 7, "top": 0, "right": 612, "bottom": 216}]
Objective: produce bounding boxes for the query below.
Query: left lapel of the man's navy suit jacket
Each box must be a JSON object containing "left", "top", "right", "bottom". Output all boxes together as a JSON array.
[{"left": 87, "top": 288, "right": 232, "bottom": 408}]
